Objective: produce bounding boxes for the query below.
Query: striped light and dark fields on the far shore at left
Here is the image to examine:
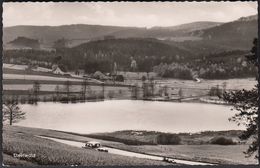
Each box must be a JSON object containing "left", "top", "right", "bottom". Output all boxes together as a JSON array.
[{"left": 2, "top": 68, "right": 134, "bottom": 101}]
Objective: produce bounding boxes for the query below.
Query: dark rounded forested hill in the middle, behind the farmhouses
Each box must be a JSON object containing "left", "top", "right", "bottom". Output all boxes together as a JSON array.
[{"left": 64, "top": 38, "right": 192, "bottom": 71}]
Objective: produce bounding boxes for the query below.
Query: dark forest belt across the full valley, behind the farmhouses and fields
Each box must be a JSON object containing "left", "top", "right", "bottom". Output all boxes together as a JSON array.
[{"left": 3, "top": 38, "right": 256, "bottom": 79}]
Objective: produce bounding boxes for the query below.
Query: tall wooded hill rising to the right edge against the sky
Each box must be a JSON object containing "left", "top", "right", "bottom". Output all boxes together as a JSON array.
[{"left": 164, "top": 15, "right": 258, "bottom": 57}]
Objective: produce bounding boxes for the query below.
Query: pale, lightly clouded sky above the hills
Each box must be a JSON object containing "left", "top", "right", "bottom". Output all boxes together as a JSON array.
[{"left": 3, "top": 1, "right": 257, "bottom": 28}]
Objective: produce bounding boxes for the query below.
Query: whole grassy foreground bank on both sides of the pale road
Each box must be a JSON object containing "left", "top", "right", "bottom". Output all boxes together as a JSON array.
[{"left": 3, "top": 126, "right": 257, "bottom": 165}]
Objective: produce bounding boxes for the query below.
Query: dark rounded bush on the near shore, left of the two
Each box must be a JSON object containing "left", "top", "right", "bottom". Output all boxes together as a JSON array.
[{"left": 156, "top": 133, "right": 181, "bottom": 145}]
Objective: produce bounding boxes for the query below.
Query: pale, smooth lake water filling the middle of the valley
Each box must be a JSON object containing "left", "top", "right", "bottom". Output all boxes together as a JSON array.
[{"left": 16, "top": 100, "right": 244, "bottom": 133}]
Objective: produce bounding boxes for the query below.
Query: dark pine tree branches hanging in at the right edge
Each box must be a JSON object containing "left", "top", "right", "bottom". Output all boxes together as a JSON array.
[{"left": 223, "top": 39, "right": 260, "bottom": 158}]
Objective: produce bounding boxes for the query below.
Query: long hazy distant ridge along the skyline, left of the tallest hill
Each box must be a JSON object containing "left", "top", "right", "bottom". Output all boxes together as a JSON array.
[{"left": 3, "top": 22, "right": 219, "bottom": 44}]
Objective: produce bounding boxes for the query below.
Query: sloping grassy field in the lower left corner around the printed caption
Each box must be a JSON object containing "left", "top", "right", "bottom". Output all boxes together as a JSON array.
[{"left": 3, "top": 126, "right": 170, "bottom": 166}]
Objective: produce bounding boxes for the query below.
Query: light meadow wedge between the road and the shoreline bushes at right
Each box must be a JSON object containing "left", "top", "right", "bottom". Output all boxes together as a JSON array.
[{"left": 105, "top": 144, "right": 257, "bottom": 164}]
